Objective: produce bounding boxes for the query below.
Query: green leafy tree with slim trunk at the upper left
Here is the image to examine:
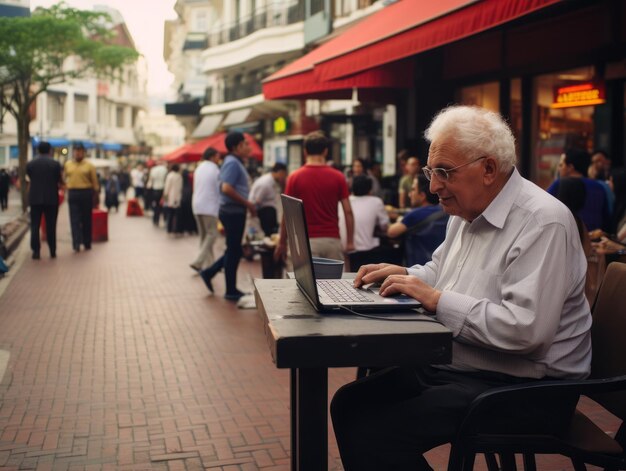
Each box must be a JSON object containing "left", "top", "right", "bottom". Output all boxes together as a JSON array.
[{"left": 0, "top": 2, "right": 139, "bottom": 211}]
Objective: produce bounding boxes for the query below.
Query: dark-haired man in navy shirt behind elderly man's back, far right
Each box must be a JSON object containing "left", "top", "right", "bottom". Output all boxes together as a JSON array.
[{"left": 548, "top": 148, "right": 611, "bottom": 232}]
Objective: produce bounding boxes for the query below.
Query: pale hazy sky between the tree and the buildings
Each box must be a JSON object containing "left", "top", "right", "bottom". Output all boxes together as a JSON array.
[{"left": 30, "top": 0, "right": 176, "bottom": 101}]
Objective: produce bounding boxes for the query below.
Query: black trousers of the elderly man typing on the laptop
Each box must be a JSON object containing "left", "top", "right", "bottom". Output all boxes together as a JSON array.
[{"left": 331, "top": 367, "right": 576, "bottom": 471}]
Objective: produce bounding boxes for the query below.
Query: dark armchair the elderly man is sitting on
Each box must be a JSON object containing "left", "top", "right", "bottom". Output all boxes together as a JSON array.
[{"left": 448, "top": 263, "right": 626, "bottom": 471}]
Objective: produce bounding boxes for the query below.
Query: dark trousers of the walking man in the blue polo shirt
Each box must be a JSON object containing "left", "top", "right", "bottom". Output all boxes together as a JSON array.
[{"left": 205, "top": 210, "right": 246, "bottom": 295}]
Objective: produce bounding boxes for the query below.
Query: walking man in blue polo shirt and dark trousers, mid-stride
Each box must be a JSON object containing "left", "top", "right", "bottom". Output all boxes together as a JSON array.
[{"left": 200, "top": 131, "right": 256, "bottom": 301}]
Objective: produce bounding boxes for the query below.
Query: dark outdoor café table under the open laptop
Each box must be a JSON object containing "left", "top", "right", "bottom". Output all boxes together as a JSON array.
[{"left": 254, "top": 279, "right": 452, "bottom": 471}]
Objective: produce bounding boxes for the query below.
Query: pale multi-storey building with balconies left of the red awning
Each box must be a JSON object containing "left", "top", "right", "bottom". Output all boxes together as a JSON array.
[{"left": 165, "top": 0, "right": 384, "bottom": 168}]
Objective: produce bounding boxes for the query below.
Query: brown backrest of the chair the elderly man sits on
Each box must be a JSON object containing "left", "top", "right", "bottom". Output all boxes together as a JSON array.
[{"left": 591, "top": 263, "right": 626, "bottom": 419}]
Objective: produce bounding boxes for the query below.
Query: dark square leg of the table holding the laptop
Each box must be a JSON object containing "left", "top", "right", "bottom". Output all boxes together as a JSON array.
[{"left": 291, "top": 368, "right": 328, "bottom": 471}]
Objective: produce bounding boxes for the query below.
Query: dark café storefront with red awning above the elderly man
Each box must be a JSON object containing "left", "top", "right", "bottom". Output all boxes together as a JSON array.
[{"left": 263, "top": 0, "right": 626, "bottom": 187}]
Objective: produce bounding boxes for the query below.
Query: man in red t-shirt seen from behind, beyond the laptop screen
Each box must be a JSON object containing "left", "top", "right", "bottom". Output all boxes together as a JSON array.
[{"left": 276, "top": 131, "right": 354, "bottom": 260}]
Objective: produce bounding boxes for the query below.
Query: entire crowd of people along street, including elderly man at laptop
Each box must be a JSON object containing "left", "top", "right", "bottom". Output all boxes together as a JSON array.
[{"left": 11, "top": 106, "right": 626, "bottom": 470}]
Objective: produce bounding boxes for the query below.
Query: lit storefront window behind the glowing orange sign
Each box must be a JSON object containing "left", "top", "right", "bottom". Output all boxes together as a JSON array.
[{"left": 533, "top": 67, "right": 595, "bottom": 188}]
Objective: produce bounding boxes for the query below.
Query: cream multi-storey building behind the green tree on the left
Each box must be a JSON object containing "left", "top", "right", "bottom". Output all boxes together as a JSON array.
[{"left": 0, "top": 7, "right": 149, "bottom": 167}]
